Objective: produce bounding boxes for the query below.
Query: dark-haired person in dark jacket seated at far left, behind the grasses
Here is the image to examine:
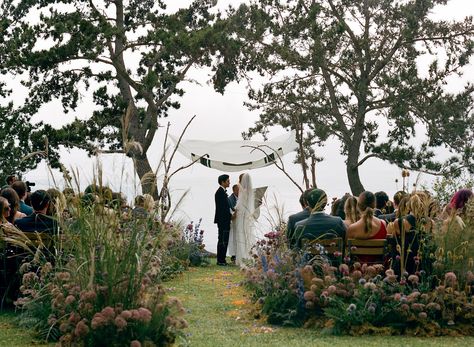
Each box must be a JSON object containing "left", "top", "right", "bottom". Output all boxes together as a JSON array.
[{"left": 15, "top": 190, "right": 58, "bottom": 233}]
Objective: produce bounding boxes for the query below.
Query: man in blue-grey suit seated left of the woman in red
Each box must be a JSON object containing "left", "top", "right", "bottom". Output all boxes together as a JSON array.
[{"left": 292, "top": 188, "right": 346, "bottom": 248}]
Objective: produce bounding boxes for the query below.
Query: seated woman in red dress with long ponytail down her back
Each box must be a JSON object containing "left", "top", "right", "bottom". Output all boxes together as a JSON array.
[{"left": 347, "top": 191, "right": 387, "bottom": 240}]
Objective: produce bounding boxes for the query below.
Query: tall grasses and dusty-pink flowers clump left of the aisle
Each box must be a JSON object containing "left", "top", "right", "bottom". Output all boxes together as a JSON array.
[{"left": 12, "top": 197, "right": 186, "bottom": 346}]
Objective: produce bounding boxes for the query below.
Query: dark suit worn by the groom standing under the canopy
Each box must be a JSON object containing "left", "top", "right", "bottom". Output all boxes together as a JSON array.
[{"left": 214, "top": 187, "right": 232, "bottom": 264}]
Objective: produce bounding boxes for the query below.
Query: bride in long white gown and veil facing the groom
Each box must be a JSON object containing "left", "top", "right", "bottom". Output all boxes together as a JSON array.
[{"left": 233, "top": 173, "right": 257, "bottom": 265}]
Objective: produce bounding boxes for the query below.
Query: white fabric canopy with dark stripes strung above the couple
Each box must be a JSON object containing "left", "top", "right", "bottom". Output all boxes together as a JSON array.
[{"left": 170, "top": 131, "right": 297, "bottom": 172}]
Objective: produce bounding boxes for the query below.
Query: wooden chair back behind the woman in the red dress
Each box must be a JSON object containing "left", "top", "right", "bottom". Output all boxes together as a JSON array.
[{"left": 347, "top": 239, "right": 387, "bottom": 264}]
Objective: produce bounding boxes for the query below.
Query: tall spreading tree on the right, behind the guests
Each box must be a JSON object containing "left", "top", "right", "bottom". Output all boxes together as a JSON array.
[{"left": 236, "top": 0, "right": 474, "bottom": 194}]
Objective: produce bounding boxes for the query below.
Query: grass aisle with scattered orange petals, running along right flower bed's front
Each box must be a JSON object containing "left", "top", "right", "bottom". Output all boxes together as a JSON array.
[{"left": 166, "top": 265, "right": 474, "bottom": 347}]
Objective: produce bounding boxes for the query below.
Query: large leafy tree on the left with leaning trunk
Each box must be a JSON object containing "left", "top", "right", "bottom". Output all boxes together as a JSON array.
[{"left": 0, "top": 0, "right": 239, "bottom": 196}]
